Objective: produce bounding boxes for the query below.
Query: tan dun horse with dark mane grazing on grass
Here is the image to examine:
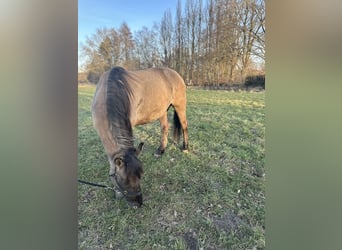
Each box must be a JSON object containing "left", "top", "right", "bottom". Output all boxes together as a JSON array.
[{"left": 91, "top": 67, "right": 188, "bottom": 207}]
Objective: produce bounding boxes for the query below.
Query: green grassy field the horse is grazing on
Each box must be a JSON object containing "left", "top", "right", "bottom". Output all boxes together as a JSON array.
[{"left": 78, "top": 85, "right": 265, "bottom": 250}]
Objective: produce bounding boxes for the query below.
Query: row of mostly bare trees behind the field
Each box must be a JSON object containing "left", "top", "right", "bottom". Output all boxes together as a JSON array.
[{"left": 81, "top": 0, "right": 265, "bottom": 85}]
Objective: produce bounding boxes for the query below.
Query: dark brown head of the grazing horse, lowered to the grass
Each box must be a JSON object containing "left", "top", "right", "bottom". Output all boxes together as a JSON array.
[{"left": 109, "top": 143, "right": 144, "bottom": 207}]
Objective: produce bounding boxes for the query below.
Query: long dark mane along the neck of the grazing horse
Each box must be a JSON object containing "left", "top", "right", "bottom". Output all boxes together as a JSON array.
[{"left": 106, "top": 67, "right": 133, "bottom": 149}]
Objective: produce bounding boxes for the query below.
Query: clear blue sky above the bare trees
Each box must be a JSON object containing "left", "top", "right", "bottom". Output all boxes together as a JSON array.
[{"left": 78, "top": 0, "right": 180, "bottom": 68}]
